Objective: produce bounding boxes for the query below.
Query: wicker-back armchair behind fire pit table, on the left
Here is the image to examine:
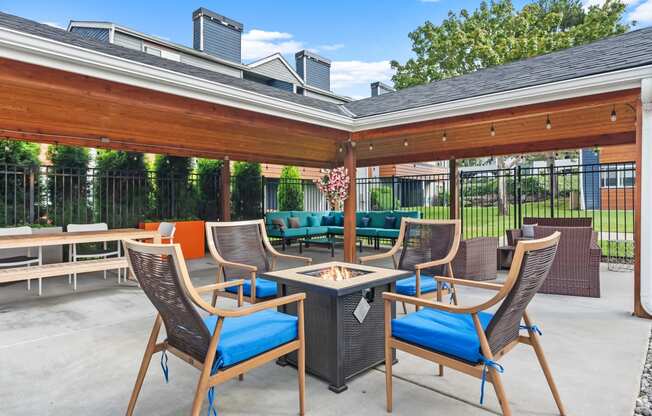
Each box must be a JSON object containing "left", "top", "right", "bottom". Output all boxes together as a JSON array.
[{"left": 206, "top": 220, "right": 312, "bottom": 305}]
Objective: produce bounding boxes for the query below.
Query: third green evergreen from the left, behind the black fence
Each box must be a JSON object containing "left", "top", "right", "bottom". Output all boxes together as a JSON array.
[{"left": 93, "top": 150, "right": 150, "bottom": 228}]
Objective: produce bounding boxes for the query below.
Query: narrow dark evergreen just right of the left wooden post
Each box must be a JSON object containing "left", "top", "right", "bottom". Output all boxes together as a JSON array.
[{"left": 231, "top": 162, "right": 263, "bottom": 220}]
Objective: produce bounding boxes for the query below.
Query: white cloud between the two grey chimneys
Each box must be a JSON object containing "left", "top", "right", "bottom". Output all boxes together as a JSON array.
[{"left": 242, "top": 29, "right": 303, "bottom": 61}]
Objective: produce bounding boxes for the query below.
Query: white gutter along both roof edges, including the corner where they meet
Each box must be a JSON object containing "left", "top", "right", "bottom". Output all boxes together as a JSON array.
[{"left": 0, "top": 27, "right": 652, "bottom": 132}]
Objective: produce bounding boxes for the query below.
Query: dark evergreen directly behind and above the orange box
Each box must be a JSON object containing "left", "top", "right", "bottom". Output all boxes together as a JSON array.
[{"left": 150, "top": 155, "right": 197, "bottom": 220}]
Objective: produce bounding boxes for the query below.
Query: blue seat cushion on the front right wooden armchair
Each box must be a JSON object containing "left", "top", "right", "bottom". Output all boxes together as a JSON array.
[{"left": 392, "top": 308, "right": 493, "bottom": 363}]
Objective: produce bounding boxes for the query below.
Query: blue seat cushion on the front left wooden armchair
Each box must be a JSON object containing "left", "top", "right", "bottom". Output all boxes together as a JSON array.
[{"left": 204, "top": 309, "right": 298, "bottom": 367}]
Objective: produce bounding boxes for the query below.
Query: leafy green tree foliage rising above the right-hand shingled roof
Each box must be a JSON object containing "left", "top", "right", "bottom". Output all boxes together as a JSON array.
[{"left": 391, "top": 0, "right": 629, "bottom": 89}]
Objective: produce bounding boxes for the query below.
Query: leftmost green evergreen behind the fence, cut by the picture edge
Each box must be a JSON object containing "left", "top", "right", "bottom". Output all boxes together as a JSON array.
[{"left": 0, "top": 139, "right": 39, "bottom": 227}]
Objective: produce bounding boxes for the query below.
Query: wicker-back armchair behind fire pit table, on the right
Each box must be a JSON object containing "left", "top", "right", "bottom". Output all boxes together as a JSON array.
[{"left": 359, "top": 218, "right": 461, "bottom": 313}]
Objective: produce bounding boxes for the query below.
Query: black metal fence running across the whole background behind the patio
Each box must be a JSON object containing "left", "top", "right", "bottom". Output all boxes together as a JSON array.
[{"left": 0, "top": 162, "right": 635, "bottom": 262}]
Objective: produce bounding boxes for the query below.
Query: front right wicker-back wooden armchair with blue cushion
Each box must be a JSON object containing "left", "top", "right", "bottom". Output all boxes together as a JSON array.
[{"left": 383, "top": 233, "right": 565, "bottom": 415}]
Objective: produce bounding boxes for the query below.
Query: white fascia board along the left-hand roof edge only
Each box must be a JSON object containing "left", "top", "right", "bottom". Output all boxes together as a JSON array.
[{"left": 0, "top": 28, "right": 351, "bottom": 130}]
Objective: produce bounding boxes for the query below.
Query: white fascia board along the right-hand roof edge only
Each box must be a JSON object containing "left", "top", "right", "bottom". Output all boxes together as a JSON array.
[{"left": 352, "top": 65, "right": 652, "bottom": 131}]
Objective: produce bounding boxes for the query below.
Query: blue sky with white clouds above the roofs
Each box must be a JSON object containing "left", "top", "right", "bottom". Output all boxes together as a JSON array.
[{"left": 0, "top": 0, "right": 652, "bottom": 98}]
